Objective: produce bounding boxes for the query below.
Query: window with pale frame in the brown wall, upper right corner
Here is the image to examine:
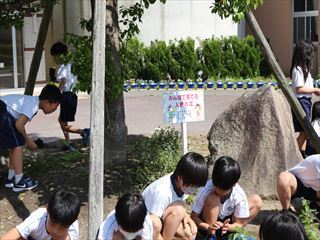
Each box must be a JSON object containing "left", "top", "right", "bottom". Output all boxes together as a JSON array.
[{"left": 293, "top": 0, "right": 318, "bottom": 44}]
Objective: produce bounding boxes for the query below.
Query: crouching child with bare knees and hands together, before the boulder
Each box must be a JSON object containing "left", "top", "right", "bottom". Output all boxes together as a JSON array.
[{"left": 191, "top": 156, "right": 262, "bottom": 238}]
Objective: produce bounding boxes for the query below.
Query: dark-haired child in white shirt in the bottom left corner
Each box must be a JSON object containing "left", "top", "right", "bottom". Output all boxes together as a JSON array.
[{"left": 1, "top": 190, "right": 80, "bottom": 240}]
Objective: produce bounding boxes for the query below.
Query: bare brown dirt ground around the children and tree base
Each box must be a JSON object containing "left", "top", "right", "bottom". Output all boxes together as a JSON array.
[{"left": 0, "top": 135, "right": 281, "bottom": 240}]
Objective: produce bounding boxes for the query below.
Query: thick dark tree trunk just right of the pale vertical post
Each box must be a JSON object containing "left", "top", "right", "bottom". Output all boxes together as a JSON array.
[{"left": 104, "top": 0, "right": 127, "bottom": 163}]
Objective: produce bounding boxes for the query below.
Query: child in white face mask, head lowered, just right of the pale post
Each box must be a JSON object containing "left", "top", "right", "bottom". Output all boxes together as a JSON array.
[{"left": 98, "top": 193, "right": 153, "bottom": 240}]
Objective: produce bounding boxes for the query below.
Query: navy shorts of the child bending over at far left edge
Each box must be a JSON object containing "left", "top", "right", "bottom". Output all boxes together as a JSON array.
[{"left": 0, "top": 100, "right": 25, "bottom": 150}]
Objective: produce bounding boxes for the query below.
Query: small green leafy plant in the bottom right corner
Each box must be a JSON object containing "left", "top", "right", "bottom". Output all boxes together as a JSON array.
[{"left": 299, "top": 199, "right": 320, "bottom": 240}]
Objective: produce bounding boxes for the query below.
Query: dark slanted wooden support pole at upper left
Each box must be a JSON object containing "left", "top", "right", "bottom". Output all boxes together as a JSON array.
[{"left": 24, "top": 1, "right": 54, "bottom": 95}]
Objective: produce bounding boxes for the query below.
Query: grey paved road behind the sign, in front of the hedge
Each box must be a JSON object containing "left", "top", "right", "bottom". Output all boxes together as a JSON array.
[{"left": 0, "top": 87, "right": 250, "bottom": 142}]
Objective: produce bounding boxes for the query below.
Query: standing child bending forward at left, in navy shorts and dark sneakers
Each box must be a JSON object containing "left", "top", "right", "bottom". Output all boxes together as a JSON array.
[{"left": 0, "top": 85, "right": 62, "bottom": 192}]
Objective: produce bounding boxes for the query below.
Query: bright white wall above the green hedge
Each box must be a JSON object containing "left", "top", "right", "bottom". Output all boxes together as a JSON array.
[{"left": 119, "top": 0, "right": 240, "bottom": 44}]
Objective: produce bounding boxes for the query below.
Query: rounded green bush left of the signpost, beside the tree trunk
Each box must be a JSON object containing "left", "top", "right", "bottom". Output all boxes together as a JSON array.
[{"left": 132, "top": 127, "right": 182, "bottom": 187}]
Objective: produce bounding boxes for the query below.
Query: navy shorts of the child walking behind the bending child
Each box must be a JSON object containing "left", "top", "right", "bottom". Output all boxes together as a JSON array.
[{"left": 59, "top": 92, "right": 78, "bottom": 122}]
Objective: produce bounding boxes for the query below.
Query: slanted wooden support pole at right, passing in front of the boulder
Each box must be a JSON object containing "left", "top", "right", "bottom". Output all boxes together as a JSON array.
[{"left": 245, "top": 12, "right": 320, "bottom": 153}]
